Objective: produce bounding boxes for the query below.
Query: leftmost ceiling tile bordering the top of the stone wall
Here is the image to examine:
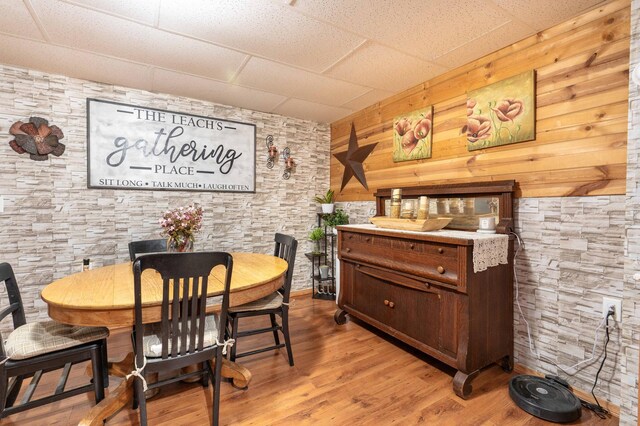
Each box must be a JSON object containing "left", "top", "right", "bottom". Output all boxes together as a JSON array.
[{"left": 0, "top": 35, "right": 151, "bottom": 90}]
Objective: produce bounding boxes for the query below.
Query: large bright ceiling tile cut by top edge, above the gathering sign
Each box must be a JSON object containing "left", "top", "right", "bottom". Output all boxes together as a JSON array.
[{"left": 160, "top": 0, "right": 364, "bottom": 72}]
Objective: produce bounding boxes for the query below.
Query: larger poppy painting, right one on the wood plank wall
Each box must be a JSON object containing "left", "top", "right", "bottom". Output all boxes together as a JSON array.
[{"left": 464, "top": 71, "right": 536, "bottom": 151}]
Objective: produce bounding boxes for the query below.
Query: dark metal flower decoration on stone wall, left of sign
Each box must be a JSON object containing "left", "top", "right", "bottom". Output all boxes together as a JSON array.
[{"left": 9, "top": 117, "right": 66, "bottom": 161}]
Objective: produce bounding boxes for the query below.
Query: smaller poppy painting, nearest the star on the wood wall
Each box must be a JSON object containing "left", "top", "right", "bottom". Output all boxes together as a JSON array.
[{"left": 393, "top": 106, "right": 433, "bottom": 163}]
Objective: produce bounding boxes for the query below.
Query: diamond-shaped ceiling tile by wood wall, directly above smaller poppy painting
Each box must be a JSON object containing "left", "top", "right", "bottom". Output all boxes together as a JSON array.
[{"left": 326, "top": 42, "right": 448, "bottom": 93}]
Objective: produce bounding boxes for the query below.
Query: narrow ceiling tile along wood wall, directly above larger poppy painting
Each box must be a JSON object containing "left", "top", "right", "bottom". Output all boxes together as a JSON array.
[{"left": 434, "top": 21, "right": 536, "bottom": 69}]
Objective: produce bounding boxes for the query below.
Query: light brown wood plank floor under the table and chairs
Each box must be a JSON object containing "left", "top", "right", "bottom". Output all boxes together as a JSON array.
[{"left": 0, "top": 296, "right": 618, "bottom": 426}]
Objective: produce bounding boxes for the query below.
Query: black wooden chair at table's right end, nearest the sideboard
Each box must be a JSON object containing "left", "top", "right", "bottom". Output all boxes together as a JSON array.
[{"left": 227, "top": 234, "right": 298, "bottom": 366}]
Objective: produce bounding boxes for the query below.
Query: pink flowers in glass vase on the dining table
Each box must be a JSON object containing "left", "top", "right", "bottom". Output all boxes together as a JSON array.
[{"left": 159, "top": 205, "right": 202, "bottom": 252}]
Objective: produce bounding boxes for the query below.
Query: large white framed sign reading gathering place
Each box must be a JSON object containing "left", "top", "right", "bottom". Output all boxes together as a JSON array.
[{"left": 87, "top": 98, "right": 256, "bottom": 192}]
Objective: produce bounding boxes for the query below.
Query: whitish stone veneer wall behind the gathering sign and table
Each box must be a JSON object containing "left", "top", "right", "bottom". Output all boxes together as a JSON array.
[{"left": 0, "top": 65, "right": 330, "bottom": 330}]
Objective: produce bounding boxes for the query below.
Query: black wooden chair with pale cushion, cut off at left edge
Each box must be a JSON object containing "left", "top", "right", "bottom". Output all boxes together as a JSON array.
[{"left": 0, "top": 263, "right": 109, "bottom": 419}]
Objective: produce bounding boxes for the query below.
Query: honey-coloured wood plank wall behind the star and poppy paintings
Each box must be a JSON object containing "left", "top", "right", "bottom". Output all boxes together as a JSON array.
[{"left": 330, "top": 0, "right": 630, "bottom": 201}]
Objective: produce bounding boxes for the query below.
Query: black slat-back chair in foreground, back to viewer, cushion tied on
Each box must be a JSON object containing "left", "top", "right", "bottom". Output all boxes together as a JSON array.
[{"left": 133, "top": 252, "right": 233, "bottom": 425}]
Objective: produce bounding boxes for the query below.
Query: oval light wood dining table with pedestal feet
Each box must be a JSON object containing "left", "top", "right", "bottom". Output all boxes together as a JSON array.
[{"left": 41, "top": 253, "right": 288, "bottom": 425}]
